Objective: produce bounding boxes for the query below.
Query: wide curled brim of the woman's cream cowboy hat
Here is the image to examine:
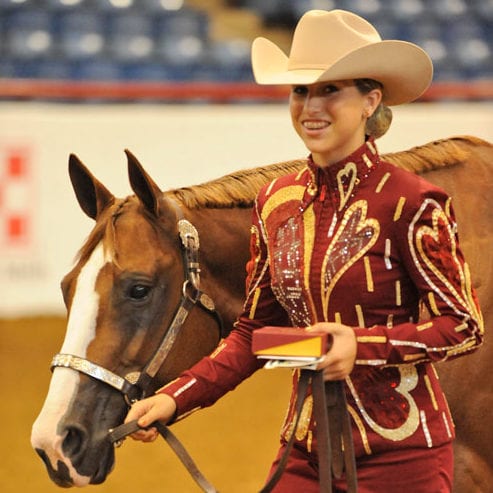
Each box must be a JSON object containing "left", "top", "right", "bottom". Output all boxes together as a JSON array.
[{"left": 252, "top": 38, "right": 433, "bottom": 106}]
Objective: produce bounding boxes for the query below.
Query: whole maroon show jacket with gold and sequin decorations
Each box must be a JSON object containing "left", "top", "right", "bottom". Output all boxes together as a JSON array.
[{"left": 159, "top": 140, "right": 483, "bottom": 458}]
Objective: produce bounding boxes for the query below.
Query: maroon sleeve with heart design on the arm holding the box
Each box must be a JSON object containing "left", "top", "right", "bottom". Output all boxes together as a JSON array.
[{"left": 355, "top": 188, "right": 484, "bottom": 365}]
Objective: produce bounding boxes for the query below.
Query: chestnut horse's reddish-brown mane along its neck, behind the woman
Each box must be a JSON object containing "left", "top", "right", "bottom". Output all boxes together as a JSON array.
[{"left": 166, "top": 136, "right": 489, "bottom": 209}]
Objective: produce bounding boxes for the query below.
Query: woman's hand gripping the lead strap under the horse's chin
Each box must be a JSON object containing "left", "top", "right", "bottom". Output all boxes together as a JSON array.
[{"left": 125, "top": 394, "right": 176, "bottom": 442}]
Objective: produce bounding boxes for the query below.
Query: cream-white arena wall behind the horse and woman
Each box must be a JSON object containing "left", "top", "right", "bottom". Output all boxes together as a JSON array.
[{"left": 0, "top": 103, "right": 493, "bottom": 318}]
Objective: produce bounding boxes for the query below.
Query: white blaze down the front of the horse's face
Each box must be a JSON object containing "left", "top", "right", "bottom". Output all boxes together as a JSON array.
[{"left": 31, "top": 244, "right": 109, "bottom": 486}]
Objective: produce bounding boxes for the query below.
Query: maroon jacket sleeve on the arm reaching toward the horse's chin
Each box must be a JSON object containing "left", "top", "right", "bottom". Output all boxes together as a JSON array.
[{"left": 158, "top": 197, "right": 289, "bottom": 420}]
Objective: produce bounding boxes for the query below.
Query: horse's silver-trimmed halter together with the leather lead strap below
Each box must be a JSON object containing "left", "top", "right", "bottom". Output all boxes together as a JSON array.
[{"left": 51, "top": 202, "right": 223, "bottom": 492}]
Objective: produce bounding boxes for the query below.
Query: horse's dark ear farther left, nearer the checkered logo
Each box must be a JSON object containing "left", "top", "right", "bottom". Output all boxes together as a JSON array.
[{"left": 68, "top": 154, "right": 115, "bottom": 219}]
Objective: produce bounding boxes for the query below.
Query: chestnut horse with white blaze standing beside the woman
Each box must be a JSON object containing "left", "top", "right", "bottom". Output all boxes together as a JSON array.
[{"left": 31, "top": 136, "right": 493, "bottom": 493}]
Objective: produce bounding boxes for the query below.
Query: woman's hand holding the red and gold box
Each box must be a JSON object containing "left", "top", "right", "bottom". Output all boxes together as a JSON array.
[{"left": 306, "top": 322, "right": 357, "bottom": 380}]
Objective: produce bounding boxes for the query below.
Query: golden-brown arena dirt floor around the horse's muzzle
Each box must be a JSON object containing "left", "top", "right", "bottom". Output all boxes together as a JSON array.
[{"left": 0, "top": 317, "right": 290, "bottom": 493}]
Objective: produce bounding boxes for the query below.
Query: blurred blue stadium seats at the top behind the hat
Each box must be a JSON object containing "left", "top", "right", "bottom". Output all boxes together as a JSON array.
[{"left": 0, "top": 0, "right": 493, "bottom": 81}]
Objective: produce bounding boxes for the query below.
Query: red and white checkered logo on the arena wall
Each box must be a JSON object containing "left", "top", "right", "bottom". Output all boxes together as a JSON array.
[{"left": 0, "top": 148, "right": 32, "bottom": 247}]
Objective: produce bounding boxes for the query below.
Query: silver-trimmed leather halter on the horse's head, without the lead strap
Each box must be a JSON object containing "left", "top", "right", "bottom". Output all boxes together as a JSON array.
[{"left": 51, "top": 202, "right": 223, "bottom": 405}]
